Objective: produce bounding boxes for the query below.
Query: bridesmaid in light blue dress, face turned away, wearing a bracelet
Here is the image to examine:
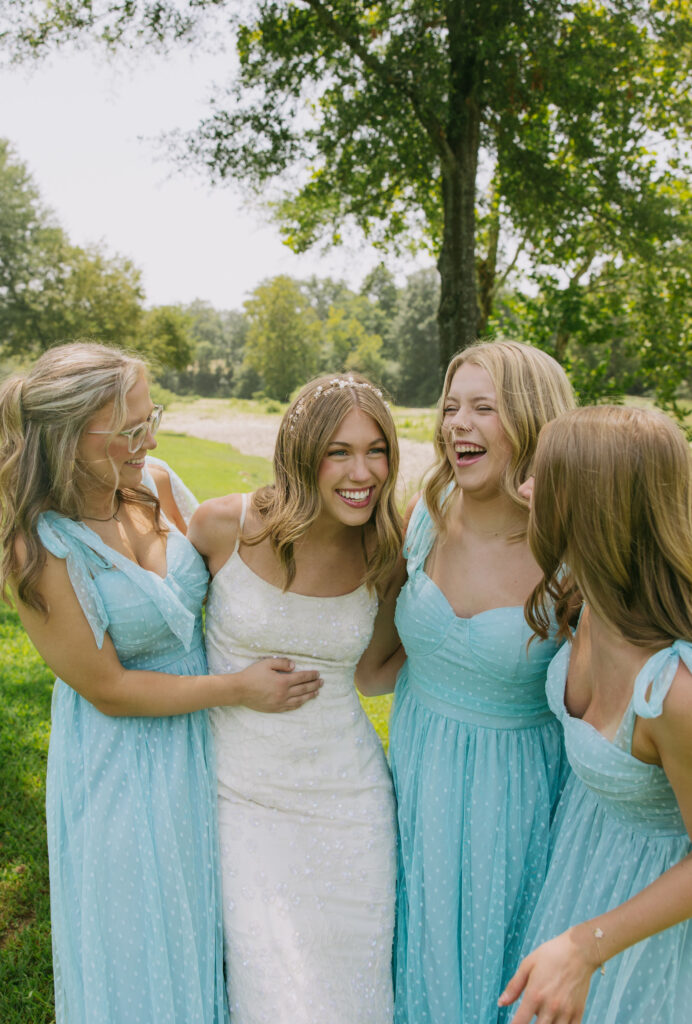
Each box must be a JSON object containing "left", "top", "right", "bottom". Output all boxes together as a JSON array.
[{"left": 501, "top": 407, "right": 692, "bottom": 1024}]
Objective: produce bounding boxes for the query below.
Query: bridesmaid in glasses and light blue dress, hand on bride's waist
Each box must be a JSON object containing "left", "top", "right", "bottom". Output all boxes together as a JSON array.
[{"left": 0, "top": 344, "right": 316, "bottom": 1024}]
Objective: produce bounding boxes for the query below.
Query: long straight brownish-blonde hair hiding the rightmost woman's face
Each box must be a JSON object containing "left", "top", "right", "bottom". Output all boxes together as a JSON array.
[{"left": 526, "top": 406, "right": 692, "bottom": 647}]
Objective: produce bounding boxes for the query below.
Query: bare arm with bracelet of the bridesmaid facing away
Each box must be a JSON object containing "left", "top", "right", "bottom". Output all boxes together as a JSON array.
[{"left": 499, "top": 665, "right": 692, "bottom": 1024}]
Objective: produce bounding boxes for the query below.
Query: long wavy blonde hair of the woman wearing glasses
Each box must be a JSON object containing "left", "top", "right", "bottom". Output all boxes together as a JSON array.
[{"left": 0, "top": 342, "right": 159, "bottom": 611}]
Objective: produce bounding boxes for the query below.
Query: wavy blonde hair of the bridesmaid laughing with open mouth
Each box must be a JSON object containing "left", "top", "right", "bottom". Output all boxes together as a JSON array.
[{"left": 425, "top": 341, "right": 575, "bottom": 536}]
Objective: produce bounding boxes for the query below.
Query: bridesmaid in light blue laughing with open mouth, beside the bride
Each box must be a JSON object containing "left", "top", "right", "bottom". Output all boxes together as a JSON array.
[{"left": 358, "top": 342, "right": 573, "bottom": 1024}]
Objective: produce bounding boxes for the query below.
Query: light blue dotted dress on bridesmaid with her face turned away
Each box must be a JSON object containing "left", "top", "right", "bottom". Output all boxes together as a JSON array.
[{"left": 515, "top": 640, "right": 692, "bottom": 1024}]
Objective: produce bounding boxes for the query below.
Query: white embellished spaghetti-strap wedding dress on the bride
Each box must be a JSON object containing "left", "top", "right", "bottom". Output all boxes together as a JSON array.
[{"left": 207, "top": 499, "right": 395, "bottom": 1024}]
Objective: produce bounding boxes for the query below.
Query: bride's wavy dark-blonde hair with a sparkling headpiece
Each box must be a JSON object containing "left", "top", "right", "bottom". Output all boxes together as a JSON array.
[{"left": 249, "top": 373, "right": 401, "bottom": 589}]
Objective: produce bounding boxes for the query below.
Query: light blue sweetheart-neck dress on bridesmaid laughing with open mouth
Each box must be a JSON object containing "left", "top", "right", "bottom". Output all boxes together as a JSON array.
[{"left": 390, "top": 501, "right": 566, "bottom": 1024}]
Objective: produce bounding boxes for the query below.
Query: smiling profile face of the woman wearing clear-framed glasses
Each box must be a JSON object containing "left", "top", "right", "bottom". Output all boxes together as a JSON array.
[{"left": 77, "top": 377, "right": 157, "bottom": 490}]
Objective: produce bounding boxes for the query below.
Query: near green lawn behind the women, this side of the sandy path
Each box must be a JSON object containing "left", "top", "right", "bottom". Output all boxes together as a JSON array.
[{"left": 0, "top": 433, "right": 391, "bottom": 1024}]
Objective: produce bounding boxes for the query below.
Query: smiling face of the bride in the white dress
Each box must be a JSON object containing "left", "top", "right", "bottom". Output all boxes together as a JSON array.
[{"left": 317, "top": 408, "right": 389, "bottom": 526}]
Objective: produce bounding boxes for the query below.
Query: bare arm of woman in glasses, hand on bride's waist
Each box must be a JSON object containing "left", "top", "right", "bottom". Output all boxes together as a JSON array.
[{"left": 15, "top": 554, "right": 321, "bottom": 716}]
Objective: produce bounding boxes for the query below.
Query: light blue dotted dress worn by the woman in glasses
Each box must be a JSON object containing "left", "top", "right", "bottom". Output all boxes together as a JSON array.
[{"left": 39, "top": 512, "right": 227, "bottom": 1024}]
